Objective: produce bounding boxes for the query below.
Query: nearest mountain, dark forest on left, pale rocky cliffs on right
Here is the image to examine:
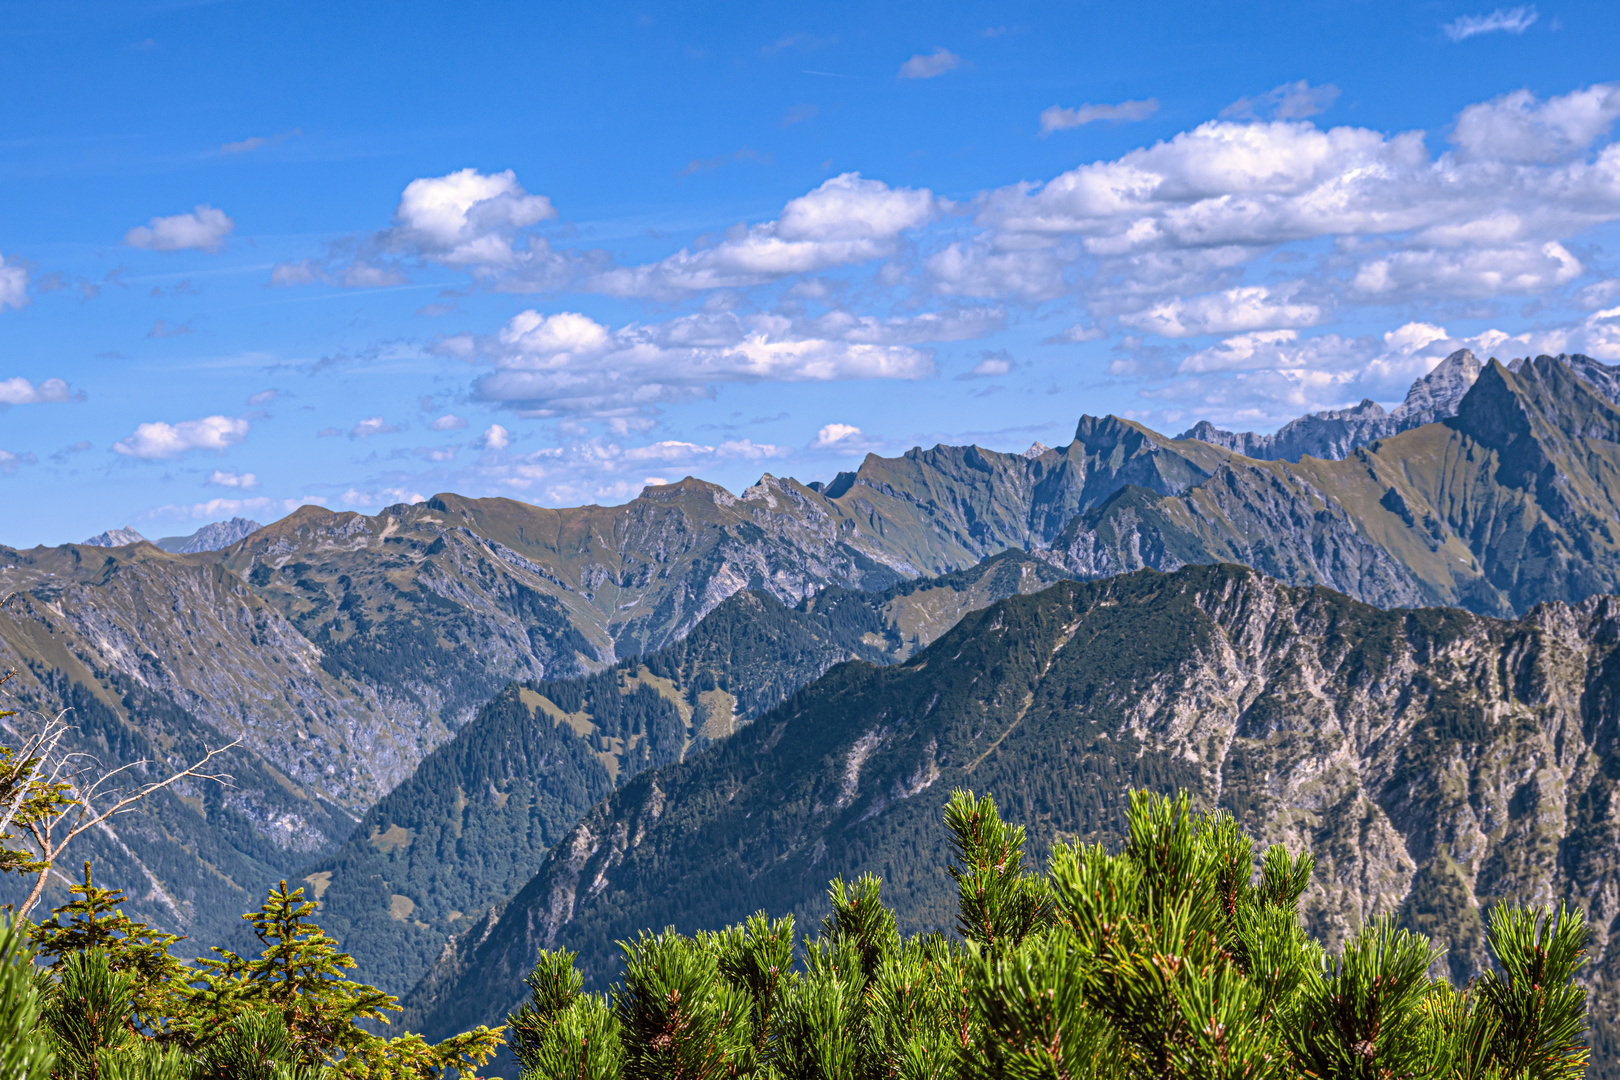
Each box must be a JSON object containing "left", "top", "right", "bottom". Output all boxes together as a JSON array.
[{"left": 407, "top": 565, "right": 1620, "bottom": 1068}]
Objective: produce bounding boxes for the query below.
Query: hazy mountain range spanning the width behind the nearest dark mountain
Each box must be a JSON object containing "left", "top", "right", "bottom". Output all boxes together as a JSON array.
[{"left": 0, "top": 348, "right": 1620, "bottom": 1075}]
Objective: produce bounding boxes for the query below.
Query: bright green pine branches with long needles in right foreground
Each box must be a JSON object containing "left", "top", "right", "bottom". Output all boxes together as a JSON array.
[{"left": 510, "top": 792, "right": 1588, "bottom": 1080}]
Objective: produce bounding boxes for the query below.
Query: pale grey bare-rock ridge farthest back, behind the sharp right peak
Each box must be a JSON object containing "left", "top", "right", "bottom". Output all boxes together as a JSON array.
[{"left": 1176, "top": 348, "right": 1483, "bottom": 461}]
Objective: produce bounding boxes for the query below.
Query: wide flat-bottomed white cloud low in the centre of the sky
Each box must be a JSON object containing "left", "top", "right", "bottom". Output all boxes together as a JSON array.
[{"left": 456, "top": 311, "right": 935, "bottom": 416}]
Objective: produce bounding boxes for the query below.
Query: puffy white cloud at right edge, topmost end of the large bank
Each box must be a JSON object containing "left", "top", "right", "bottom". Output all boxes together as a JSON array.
[{"left": 1452, "top": 83, "right": 1620, "bottom": 162}]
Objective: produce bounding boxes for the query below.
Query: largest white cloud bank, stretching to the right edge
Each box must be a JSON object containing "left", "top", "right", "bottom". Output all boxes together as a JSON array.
[{"left": 959, "top": 84, "right": 1620, "bottom": 320}]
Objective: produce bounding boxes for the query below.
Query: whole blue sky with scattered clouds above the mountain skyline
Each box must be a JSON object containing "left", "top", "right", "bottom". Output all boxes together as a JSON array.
[{"left": 0, "top": 0, "right": 1620, "bottom": 544}]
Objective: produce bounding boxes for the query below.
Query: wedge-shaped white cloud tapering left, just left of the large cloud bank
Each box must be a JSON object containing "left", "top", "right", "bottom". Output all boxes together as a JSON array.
[{"left": 588, "top": 173, "right": 940, "bottom": 296}]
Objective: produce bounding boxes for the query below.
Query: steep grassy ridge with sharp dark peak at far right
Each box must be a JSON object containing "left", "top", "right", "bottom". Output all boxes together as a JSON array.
[{"left": 1053, "top": 356, "right": 1620, "bottom": 615}]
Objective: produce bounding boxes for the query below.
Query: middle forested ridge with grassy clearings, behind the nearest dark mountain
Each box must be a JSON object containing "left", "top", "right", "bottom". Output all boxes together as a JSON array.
[{"left": 300, "top": 552, "right": 1058, "bottom": 994}]
